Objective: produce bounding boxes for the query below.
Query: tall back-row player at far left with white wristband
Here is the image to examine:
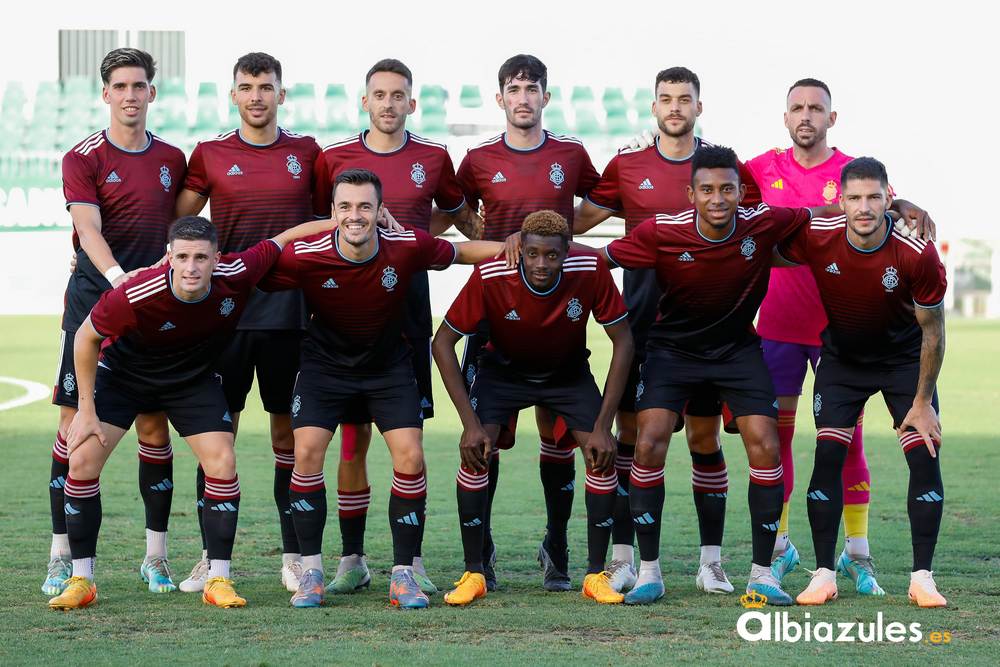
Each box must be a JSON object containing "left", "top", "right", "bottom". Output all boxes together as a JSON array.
[{"left": 42, "top": 48, "right": 184, "bottom": 595}]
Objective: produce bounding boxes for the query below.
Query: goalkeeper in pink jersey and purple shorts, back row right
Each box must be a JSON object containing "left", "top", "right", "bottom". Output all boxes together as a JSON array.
[{"left": 747, "top": 79, "right": 927, "bottom": 595}]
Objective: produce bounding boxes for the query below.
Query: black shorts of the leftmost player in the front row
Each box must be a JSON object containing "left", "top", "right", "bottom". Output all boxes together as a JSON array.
[{"left": 94, "top": 366, "right": 233, "bottom": 438}]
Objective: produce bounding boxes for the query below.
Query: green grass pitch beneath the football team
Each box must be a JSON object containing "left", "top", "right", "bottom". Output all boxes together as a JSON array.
[{"left": 0, "top": 317, "right": 1000, "bottom": 665}]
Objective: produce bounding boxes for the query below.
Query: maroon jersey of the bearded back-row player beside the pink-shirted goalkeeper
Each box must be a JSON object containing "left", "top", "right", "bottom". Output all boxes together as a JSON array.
[{"left": 587, "top": 137, "right": 761, "bottom": 233}]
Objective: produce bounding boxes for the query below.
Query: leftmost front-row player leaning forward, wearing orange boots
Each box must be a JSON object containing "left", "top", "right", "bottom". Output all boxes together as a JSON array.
[{"left": 49, "top": 216, "right": 331, "bottom": 610}]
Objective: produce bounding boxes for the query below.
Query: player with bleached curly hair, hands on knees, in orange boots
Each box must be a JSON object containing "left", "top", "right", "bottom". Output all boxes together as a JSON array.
[{"left": 434, "top": 211, "right": 632, "bottom": 605}]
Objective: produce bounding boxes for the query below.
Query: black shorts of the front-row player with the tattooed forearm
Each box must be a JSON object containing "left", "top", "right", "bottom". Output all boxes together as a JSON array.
[{"left": 813, "top": 350, "right": 940, "bottom": 428}]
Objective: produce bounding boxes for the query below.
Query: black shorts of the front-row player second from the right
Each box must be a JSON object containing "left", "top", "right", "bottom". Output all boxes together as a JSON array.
[{"left": 636, "top": 341, "right": 778, "bottom": 419}]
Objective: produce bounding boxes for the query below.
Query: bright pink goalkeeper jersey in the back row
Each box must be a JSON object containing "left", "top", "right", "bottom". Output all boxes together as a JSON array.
[{"left": 746, "top": 148, "right": 853, "bottom": 345}]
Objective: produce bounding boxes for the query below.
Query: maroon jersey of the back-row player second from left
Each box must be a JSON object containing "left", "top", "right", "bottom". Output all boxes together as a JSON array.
[{"left": 184, "top": 128, "right": 319, "bottom": 330}]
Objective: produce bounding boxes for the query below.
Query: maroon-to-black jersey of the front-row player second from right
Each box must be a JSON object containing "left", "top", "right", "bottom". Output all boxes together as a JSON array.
[{"left": 606, "top": 204, "right": 809, "bottom": 359}]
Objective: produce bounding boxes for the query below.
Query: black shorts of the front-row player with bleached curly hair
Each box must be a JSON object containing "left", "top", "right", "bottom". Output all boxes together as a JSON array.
[{"left": 469, "top": 365, "right": 601, "bottom": 433}]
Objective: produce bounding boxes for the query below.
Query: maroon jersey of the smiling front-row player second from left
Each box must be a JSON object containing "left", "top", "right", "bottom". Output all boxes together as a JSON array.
[{"left": 261, "top": 229, "right": 456, "bottom": 373}]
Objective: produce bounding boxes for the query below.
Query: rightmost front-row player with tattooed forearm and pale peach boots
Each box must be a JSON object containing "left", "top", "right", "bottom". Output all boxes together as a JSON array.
[{"left": 779, "top": 158, "right": 947, "bottom": 607}]
